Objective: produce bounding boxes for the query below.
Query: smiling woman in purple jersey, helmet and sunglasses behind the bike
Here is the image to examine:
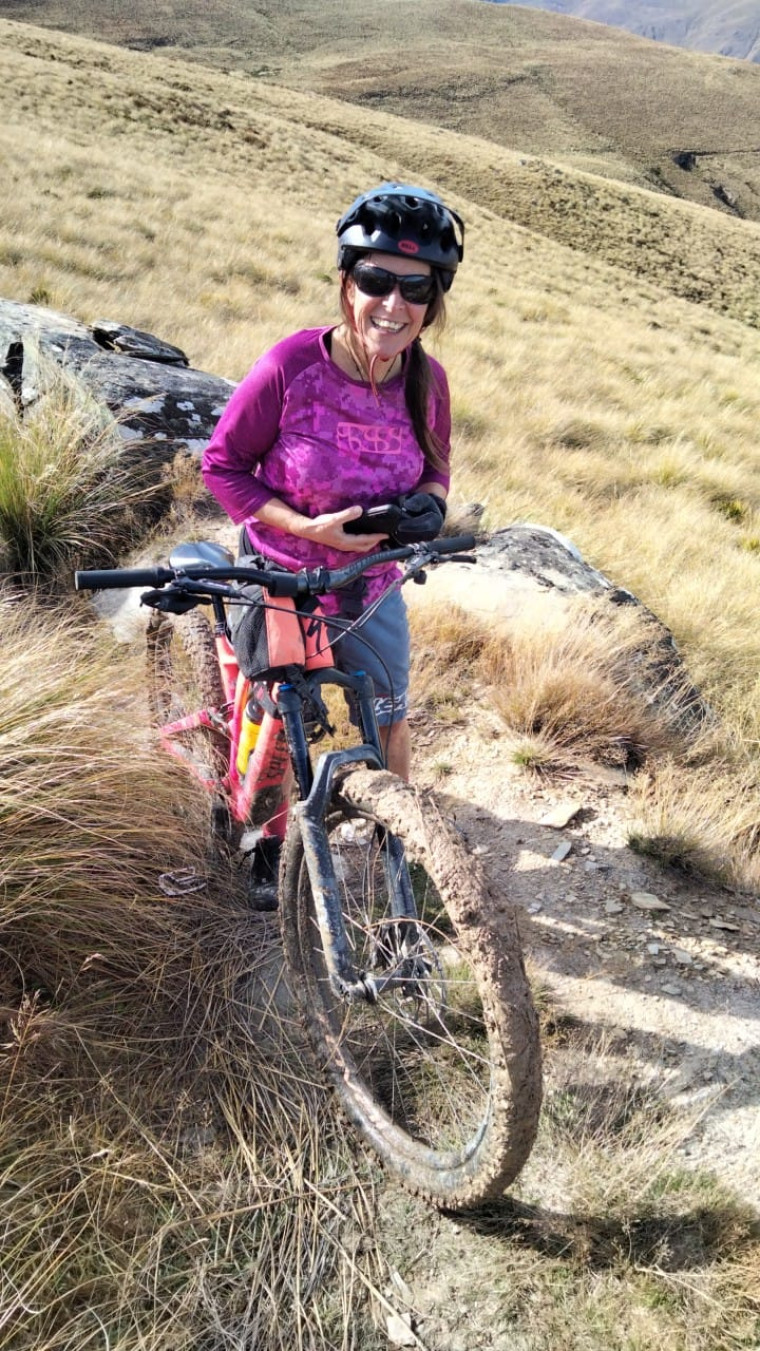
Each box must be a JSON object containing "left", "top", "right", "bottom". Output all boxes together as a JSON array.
[{"left": 202, "top": 182, "right": 464, "bottom": 897}]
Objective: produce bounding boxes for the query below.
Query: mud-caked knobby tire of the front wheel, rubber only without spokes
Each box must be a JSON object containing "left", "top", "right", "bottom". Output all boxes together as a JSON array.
[{"left": 281, "top": 767, "right": 541, "bottom": 1210}]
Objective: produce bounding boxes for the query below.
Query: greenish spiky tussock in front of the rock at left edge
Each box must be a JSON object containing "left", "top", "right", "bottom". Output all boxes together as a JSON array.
[{"left": 0, "top": 359, "right": 155, "bottom": 588}]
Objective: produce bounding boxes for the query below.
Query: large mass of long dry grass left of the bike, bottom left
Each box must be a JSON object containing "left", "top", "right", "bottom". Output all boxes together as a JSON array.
[{"left": 0, "top": 600, "right": 373, "bottom": 1351}]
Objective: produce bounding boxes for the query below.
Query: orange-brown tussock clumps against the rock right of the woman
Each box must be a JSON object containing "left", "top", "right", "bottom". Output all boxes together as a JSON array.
[{"left": 413, "top": 601, "right": 701, "bottom": 773}]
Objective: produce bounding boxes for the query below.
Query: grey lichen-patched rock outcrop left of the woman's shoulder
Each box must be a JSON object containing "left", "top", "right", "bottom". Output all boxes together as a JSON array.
[{"left": 0, "top": 300, "right": 235, "bottom": 470}]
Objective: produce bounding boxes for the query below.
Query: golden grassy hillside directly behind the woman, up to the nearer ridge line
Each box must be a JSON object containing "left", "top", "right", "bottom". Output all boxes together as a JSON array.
[{"left": 0, "top": 15, "right": 760, "bottom": 761}]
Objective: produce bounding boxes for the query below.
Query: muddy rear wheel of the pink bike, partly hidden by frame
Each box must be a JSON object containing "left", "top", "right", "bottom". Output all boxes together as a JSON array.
[{"left": 146, "top": 609, "right": 234, "bottom": 843}]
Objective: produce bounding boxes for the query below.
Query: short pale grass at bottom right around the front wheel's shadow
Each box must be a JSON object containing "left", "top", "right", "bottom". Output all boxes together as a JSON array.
[{"left": 379, "top": 1009, "right": 760, "bottom": 1351}]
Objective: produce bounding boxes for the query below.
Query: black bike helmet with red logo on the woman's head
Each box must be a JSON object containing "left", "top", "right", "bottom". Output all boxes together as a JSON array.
[{"left": 335, "top": 182, "right": 464, "bottom": 290}]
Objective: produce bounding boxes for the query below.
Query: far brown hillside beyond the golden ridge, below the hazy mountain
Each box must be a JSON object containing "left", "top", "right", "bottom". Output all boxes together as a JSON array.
[{"left": 0, "top": 0, "right": 760, "bottom": 219}]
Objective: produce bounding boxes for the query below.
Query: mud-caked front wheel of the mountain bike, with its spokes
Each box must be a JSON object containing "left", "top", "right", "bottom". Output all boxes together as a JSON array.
[{"left": 281, "top": 767, "right": 541, "bottom": 1209}]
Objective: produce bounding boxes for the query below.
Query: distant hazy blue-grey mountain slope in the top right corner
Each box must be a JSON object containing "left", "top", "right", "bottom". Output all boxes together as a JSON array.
[{"left": 491, "top": 0, "right": 760, "bottom": 61}]
